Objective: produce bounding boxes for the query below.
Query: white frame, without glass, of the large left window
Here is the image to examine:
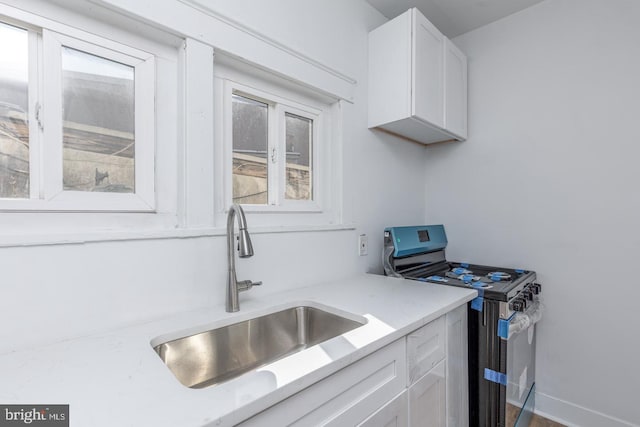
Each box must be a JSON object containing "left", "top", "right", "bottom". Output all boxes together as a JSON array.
[{"left": 0, "top": 8, "right": 156, "bottom": 212}]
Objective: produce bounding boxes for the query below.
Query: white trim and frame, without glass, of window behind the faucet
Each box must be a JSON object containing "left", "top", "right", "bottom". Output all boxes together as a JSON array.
[{"left": 214, "top": 54, "right": 342, "bottom": 229}]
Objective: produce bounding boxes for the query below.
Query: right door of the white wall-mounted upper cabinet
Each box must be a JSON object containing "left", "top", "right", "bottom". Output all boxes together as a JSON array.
[{"left": 444, "top": 39, "right": 467, "bottom": 139}]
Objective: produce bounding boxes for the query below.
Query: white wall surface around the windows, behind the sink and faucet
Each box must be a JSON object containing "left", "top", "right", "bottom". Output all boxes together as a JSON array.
[{"left": 0, "top": 0, "right": 426, "bottom": 353}]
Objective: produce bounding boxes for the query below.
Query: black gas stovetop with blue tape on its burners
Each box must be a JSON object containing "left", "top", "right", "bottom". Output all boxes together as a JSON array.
[{"left": 403, "top": 262, "right": 536, "bottom": 301}]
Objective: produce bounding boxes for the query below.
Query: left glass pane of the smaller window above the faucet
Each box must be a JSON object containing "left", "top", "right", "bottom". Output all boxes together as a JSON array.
[{"left": 233, "top": 95, "right": 269, "bottom": 205}]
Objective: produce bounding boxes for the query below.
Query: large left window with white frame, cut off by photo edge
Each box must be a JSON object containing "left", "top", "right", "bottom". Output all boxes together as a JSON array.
[{"left": 0, "top": 9, "right": 155, "bottom": 211}]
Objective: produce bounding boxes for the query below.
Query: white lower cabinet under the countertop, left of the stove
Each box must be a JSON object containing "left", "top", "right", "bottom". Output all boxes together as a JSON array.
[{"left": 240, "top": 304, "right": 468, "bottom": 427}]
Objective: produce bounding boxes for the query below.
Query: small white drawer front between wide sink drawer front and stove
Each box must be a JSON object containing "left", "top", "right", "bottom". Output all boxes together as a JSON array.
[{"left": 407, "top": 316, "right": 446, "bottom": 385}]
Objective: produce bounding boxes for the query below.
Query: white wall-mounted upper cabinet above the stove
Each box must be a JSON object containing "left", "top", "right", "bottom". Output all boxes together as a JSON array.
[{"left": 368, "top": 8, "right": 467, "bottom": 144}]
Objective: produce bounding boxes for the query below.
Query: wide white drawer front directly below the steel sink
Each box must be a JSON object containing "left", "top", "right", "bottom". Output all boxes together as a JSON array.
[{"left": 241, "top": 339, "right": 406, "bottom": 427}]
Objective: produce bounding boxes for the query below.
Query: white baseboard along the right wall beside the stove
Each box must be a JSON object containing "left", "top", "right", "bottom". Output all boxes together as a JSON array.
[{"left": 535, "top": 391, "right": 640, "bottom": 427}]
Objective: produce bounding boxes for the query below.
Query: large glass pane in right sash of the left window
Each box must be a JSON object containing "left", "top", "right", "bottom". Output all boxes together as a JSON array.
[{"left": 62, "top": 47, "right": 135, "bottom": 193}]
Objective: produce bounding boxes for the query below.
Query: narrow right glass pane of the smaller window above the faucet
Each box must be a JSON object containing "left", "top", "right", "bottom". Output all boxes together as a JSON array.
[{"left": 285, "top": 113, "right": 313, "bottom": 200}]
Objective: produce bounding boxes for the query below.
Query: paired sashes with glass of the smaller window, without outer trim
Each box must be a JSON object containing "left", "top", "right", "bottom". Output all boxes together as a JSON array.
[{"left": 231, "top": 88, "right": 321, "bottom": 206}]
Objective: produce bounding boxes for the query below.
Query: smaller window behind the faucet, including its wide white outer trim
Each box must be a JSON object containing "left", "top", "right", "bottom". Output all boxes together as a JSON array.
[{"left": 214, "top": 53, "right": 342, "bottom": 231}]
